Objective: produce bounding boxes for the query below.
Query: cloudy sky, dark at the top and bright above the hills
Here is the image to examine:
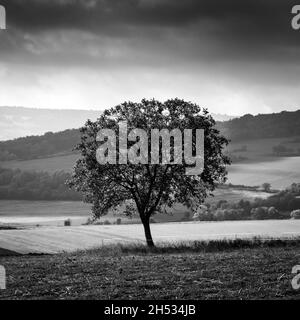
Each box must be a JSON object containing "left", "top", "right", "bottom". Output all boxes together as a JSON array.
[{"left": 0, "top": 0, "right": 300, "bottom": 115}]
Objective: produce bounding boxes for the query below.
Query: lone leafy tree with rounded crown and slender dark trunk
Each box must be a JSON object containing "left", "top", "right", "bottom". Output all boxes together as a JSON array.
[{"left": 69, "top": 99, "right": 230, "bottom": 247}]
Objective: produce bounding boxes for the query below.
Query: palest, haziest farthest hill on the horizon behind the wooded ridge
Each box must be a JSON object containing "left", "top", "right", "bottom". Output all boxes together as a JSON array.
[{"left": 0, "top": 107, "right": 234, "bottom": 141}]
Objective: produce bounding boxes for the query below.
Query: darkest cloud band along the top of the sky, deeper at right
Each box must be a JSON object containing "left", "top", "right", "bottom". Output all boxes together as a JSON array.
[{"left": 0, "top": 0, "right": 300, "bottom": 60}]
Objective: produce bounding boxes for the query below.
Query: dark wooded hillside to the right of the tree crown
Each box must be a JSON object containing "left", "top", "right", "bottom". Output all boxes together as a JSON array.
[{"left": 218, "top": 110, "right": 300, "bottom": 142}]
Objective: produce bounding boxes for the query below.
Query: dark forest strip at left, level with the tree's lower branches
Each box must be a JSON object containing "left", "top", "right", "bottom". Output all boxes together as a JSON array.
[{"left": 0, "top": 168, "right": 82, "bottom": 200}]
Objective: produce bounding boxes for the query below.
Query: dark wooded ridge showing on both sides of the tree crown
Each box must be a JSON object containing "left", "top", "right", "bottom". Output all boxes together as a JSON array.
[{"left": 0, "top": 110, "right": 300, "bottom": 161}]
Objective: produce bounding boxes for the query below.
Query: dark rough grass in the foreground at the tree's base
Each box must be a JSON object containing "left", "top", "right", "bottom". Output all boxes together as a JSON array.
[{"left": 0, "top": 239, "right": 300, "bottom": 299}]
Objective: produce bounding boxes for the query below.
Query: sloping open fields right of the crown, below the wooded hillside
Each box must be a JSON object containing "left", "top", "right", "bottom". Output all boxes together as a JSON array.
[{"left": 228, "top": 137, "right": 300, "bottom": 189}]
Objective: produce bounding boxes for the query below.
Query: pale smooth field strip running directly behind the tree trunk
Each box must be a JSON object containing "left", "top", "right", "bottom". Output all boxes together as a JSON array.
[{"left": 0, "top": 220, "right": 300, "bottom": 254}]
